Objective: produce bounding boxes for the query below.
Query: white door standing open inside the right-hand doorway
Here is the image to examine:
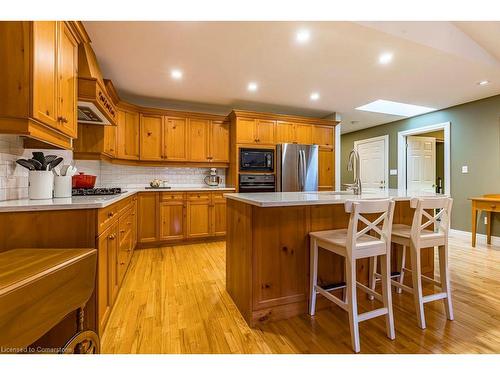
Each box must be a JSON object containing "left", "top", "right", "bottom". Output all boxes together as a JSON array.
[{"left": 406, "top": 136, "right": 436, "bottom": 192}]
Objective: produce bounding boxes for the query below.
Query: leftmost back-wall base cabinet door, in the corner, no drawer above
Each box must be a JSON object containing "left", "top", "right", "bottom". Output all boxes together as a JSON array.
[{"left": 137, "top": 193, "right": 159, "bottom": 243}]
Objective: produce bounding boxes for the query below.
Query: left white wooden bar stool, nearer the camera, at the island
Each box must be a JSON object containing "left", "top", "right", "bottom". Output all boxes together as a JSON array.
[{"left": 309, "top": 199, "right": 395, "bottom": 353}]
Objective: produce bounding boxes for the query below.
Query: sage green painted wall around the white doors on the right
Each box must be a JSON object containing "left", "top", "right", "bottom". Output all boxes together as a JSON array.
[{"left": 341, "top": 95, "right": 500, "bottom": 236}]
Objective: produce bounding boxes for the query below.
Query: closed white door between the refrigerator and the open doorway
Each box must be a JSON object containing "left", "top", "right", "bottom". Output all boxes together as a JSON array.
[{"left": 354, "top": 135, "right": 389, "bottom": 189}]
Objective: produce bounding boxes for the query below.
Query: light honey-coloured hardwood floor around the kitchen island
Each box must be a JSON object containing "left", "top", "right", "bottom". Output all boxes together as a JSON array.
[{"left": 102, "top": 235, "right": 500, "bottom": 353}]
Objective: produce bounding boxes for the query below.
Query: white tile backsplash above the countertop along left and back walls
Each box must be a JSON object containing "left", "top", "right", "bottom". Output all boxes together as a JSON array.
[{"left": 0, "top": 135, "right": 225, "bottom": 201}]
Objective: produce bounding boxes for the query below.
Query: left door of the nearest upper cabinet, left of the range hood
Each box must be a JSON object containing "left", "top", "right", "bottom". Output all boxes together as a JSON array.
[{"left": 33, "top": 21, "right": 58, "bottom": 129}]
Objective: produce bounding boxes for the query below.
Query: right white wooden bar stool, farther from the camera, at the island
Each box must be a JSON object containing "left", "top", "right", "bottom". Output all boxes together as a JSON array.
[{"left": 370, "top": 197, "right": 453, "bottom": 329}]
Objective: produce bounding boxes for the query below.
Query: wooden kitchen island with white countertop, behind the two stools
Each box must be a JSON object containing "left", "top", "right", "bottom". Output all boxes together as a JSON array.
[{"left": 225, "top": 189, "right": 444, "bottom": 326}]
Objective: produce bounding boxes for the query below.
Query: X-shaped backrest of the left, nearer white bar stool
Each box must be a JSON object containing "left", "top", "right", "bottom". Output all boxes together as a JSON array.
[{"left": 345, "top": 199, "right": 394, "bottom": 251}]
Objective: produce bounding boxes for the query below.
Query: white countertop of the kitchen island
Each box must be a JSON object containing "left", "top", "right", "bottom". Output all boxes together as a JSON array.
[{"left": 224, "top": 189, "right": 446, "bottom": 207}]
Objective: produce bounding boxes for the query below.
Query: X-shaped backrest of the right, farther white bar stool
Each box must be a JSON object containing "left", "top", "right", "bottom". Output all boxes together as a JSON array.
[{"left": 410, "top": 197, "right": 453, "bottom": 243}]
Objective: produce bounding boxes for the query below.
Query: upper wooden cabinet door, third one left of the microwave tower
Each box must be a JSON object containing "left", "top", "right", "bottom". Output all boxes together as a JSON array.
[{"left": 164, "top": 117, "right": 188, "bottom": 161}]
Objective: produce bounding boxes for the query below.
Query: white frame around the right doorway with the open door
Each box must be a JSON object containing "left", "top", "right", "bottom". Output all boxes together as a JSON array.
[{"left": 398, "top": 121, "right": 451, "bottom": 195}]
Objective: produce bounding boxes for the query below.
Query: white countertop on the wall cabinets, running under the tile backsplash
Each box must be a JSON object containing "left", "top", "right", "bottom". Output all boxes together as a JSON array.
[{"left": 0, "top": 187, "right": 235, "bottom": 212}]
